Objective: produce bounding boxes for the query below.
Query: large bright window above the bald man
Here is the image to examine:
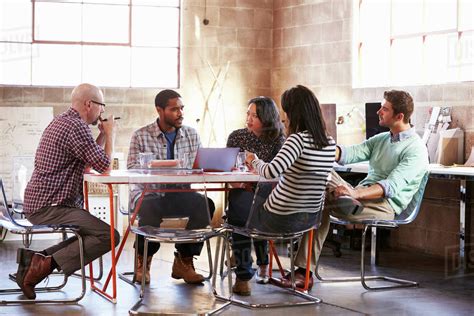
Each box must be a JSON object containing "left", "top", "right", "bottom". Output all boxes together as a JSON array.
[{"left": 0, "top": 0, "right": 180, "bottom": 88}]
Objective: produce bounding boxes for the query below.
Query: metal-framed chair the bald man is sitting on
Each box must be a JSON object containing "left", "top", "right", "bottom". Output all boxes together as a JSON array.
[{"left": 0, "top": 178, "right": 86, "bottom": 305}]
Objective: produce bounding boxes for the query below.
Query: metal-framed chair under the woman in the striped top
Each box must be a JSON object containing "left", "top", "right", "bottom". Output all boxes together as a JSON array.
[{"left": 214, "top": 180, "right": 324, "bottom": 308}]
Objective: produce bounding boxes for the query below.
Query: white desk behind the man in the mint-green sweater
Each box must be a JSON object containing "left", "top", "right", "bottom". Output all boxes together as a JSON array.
[{"left": 334, "top": 162, "right": 474, "bottom": 270}]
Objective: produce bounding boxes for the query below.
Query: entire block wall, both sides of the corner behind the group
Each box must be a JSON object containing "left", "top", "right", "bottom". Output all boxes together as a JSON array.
[{"left": 0, "top": 0, "right": 474, "bottom": 254}]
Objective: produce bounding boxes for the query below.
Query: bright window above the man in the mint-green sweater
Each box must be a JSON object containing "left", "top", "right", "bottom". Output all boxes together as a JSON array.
[{"left": 353, "top": 0, "right": 474, "bottom": 88}]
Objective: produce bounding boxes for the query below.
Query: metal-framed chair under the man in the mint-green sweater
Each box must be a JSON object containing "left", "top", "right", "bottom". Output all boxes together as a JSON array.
[{"left": 315, "top": 171, "right": 429, "bottom": 290}]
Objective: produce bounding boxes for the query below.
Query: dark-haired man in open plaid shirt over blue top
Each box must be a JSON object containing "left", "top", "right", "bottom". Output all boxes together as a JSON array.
[{"left": 127, "top": 90, "right": 215, "bottom": 284}]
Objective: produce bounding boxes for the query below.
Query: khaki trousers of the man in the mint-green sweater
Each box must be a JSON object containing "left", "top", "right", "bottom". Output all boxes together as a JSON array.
[{"left": 295, "top": 170, "right": 395, "bottom": 271}]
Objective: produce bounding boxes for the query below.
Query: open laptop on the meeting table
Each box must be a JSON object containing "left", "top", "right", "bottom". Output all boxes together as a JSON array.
[{"left": 193, "top": 147, "right": 240, "bottom": 171}]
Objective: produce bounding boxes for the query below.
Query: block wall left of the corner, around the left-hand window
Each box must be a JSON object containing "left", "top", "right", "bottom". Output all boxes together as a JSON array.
[{"left": 0, "top": 0, "right": 273, "bottom": 155}]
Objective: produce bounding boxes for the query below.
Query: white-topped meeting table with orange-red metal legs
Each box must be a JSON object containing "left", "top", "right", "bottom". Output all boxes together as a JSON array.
[{"left": 84, "top": 169, "right": 261, "bottom": 303}]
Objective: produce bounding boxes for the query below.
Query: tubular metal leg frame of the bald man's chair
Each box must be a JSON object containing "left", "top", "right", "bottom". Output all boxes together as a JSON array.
[{"left": 0, "top": 231, "right": 86, "bottom": 305}]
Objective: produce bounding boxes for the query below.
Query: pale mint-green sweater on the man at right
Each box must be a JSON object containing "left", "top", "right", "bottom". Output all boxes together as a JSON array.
[{"left": 344, "top": 132, "right": 428, "bottom": 214}]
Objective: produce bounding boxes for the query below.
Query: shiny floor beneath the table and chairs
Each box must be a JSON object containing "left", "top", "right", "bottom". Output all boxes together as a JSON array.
[{"left": 0, "top": 236, "right": 474, "bottom": 316}]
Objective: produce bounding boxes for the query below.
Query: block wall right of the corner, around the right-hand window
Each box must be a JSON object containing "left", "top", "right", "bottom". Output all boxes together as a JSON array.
[{"left": 271, "top": 0, "right": 474, "bottom": 255}]
